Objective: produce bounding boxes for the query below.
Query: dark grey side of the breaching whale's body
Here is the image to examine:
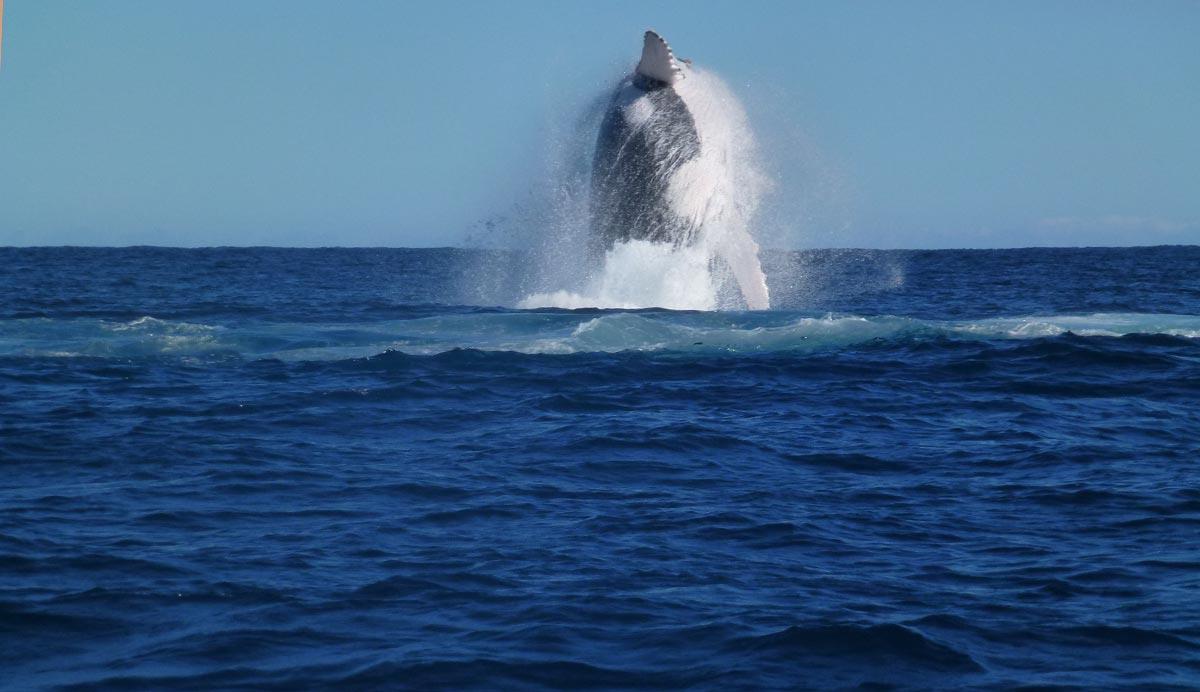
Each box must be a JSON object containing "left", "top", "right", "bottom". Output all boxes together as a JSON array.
[{"left": 592, "top": 77, "right": 700, "bottom": 252}]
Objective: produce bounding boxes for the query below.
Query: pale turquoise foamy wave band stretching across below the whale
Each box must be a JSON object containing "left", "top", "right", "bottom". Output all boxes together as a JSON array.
[{"left": 0, "top": 309, "right": 1200, "bottom": 361}]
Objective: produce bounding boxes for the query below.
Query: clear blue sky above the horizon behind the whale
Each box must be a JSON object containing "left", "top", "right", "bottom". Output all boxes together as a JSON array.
[{"left": 0, "top": 0, "right": 1200, "bottom": 247}]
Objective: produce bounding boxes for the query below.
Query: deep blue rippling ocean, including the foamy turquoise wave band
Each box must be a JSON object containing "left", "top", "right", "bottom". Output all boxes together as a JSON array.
[{"left": 0, "top": 247, "right": 1200, "bottom": 690}]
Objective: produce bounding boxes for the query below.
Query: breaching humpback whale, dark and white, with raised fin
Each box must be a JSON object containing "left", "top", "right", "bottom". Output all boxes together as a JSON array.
[{"left": 589, "top": 31, "right": 769, "bottom": 309}]
